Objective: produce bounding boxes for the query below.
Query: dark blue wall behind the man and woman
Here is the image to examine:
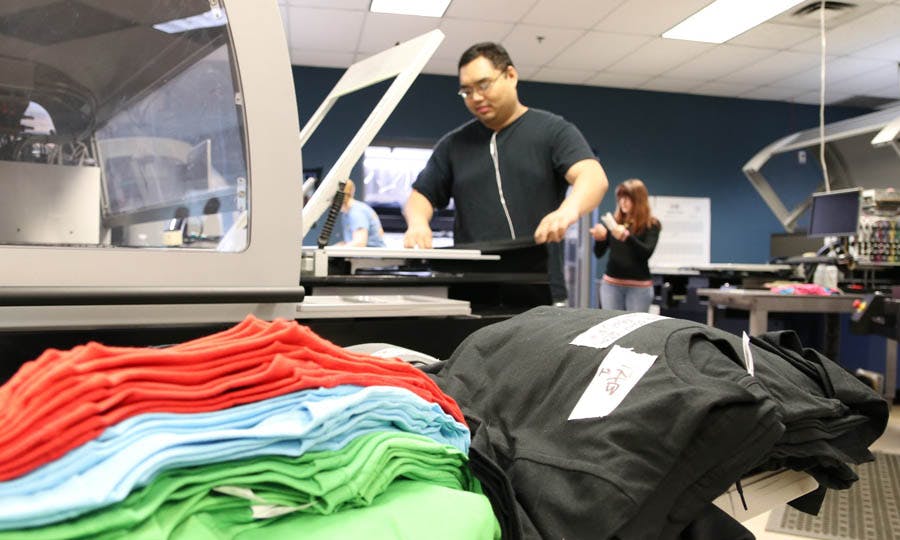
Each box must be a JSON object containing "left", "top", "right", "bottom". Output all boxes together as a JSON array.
[{"left": 293, "top": 66, "right": 868, "bottom": 263}]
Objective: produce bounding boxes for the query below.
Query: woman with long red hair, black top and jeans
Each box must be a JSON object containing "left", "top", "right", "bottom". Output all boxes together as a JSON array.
[{"left": 591, "top": 178, "right": 662, "bottom": 311}]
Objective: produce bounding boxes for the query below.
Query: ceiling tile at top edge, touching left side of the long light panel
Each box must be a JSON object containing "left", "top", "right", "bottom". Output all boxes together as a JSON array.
[{"left": 594, "top": 0, "right": 710, "bottom": 36}]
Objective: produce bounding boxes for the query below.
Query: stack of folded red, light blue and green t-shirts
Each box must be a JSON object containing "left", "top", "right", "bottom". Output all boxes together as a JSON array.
[{"left": 0, "top": 317, "right": 499, "bottom": 539}]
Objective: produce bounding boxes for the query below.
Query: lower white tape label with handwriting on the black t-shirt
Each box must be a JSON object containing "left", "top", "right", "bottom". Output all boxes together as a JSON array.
[{"left": 569, "top": 345, "right": 656, "bottom": 420}]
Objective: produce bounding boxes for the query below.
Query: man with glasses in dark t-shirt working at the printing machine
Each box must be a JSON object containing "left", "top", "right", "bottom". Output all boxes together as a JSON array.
[{"left": 403, "top": 43, "right": 608, "bottom": 301}]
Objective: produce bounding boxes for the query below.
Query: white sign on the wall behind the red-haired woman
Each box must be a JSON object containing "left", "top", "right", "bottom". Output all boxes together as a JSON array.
[{"left": 650, "top": 196, "right": 712, "bottom": 268}]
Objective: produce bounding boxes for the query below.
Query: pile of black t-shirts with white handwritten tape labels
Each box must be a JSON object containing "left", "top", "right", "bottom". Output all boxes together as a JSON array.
[{"left": 427, "top": 307, "right": 888, "bottom": 539}]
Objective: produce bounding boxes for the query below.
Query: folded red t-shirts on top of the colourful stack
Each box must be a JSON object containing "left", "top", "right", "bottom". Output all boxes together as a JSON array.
[{"left": 0, "top": 316, "right": 464, "bottom": 480}]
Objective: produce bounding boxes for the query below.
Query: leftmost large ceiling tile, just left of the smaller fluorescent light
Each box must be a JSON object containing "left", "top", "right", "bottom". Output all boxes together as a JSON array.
[{"left": 288, "top": 7, "right": 365, "bottom": 52}]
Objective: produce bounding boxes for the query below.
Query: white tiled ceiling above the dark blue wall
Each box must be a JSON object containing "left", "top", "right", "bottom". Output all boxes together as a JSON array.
[{"left": 279, "top": 0, "right": 900, "bottom": 103}]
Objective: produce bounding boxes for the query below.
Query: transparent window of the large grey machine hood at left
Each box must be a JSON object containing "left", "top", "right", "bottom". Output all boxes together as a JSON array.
[{"left": 0, "top": 0, "right": 249, "bottom": 251}]
